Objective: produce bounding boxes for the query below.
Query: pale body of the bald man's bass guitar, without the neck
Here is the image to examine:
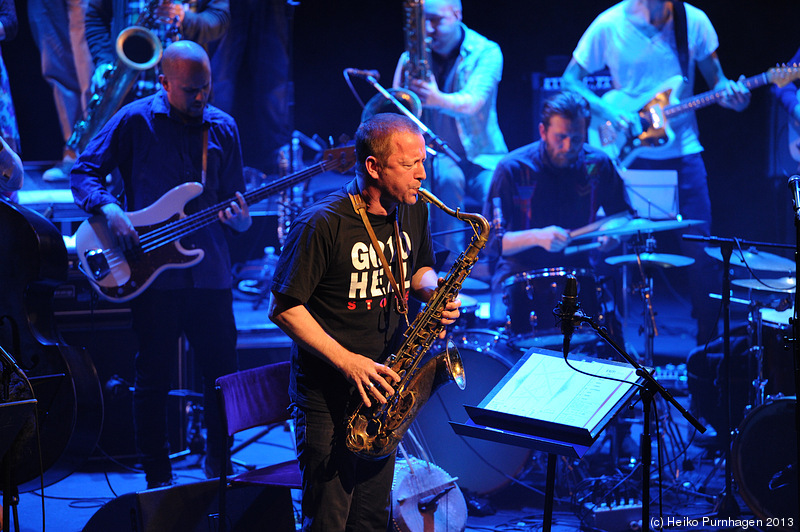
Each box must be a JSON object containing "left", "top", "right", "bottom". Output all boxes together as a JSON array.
[{"left": 75, "top": 182, "right": 204, "bottom": 302}]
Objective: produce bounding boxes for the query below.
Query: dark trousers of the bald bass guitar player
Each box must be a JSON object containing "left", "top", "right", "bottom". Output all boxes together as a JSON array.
[{"left": 131, "top": 289, "right": 237, "bottom": 482}]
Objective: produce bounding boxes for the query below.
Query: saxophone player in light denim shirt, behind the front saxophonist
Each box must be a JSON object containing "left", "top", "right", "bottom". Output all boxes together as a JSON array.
[{"left": 392, "top": 0, "right": 508, "bottom": 258}]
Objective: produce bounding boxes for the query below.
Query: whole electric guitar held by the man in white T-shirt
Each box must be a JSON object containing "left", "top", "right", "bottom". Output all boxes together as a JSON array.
[{"left": 588, "top": 65, "right": 800, "bottom": 168}]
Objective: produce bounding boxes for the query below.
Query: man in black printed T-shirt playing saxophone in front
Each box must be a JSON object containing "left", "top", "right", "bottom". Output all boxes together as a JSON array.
[{"left": 269, "top": 113, "right": 461, "bottom": 531}]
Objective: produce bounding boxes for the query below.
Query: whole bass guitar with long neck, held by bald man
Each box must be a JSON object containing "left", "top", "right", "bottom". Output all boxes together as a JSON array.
[{"left": 75, "top": 146, "right": 355, "bottom": 303}]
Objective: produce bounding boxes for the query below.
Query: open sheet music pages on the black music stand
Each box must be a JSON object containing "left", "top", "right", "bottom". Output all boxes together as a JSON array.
[{"left": 485, "top": 355, "right": 638, "bottom": 430}]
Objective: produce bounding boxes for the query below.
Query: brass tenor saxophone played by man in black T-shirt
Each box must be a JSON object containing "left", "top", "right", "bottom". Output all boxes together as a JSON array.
[{"left": 346, "top": 189, "right": 490, "bottom": 460}]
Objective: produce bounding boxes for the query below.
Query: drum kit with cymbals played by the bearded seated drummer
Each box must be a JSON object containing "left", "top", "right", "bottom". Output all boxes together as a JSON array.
[{"left": 412, "top": 217, "right": 712, "bottom": 495}]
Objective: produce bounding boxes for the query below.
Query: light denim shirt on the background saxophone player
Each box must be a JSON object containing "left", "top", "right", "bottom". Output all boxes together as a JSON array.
[{"left": 394, "top": 24, "right": 508, "bottom": 164}]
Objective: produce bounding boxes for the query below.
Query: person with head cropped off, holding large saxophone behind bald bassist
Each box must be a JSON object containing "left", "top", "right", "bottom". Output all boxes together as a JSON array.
[{"left": 86, "top": 0, "right": 230, "bottom": 101}]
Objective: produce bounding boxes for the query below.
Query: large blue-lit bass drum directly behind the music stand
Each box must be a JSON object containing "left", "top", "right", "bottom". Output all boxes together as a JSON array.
[{"left": 413, "top": 329, "right": 532, "bottom": 494}]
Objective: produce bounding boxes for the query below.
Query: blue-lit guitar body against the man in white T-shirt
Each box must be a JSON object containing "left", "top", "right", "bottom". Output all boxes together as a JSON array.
[{"left": 588, "top": 76, "right": 683, "bottom": 168}]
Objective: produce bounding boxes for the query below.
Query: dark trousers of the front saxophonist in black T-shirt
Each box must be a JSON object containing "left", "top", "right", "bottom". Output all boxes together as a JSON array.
[{"left": 294, "top": 408, "right": 396, "bottom": 532}]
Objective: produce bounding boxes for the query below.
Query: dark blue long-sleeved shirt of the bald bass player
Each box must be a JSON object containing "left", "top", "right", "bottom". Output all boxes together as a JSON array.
[{"left": 70, "top": 89, "right": 245, "bottom": 289}]
